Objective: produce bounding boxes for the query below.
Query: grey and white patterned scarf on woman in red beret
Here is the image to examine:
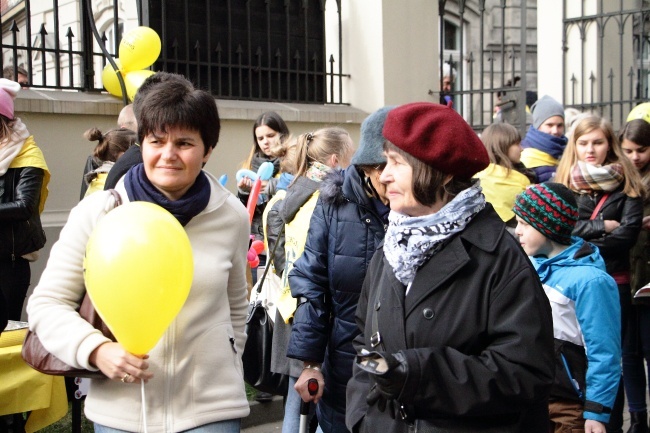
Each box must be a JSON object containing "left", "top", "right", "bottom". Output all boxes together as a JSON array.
[{"left": 384, "top": 182, "right": 485, "bottom": 286}]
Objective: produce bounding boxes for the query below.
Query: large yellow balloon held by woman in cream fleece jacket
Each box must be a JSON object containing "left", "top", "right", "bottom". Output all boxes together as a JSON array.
[{"left": 84, "top": 201, "right": 194, "bottom": 355}]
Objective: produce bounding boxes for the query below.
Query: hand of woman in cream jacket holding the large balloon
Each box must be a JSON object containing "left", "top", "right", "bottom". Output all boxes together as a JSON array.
[{"left": 89, "top": 343, "right": 153, "bottom": 383}]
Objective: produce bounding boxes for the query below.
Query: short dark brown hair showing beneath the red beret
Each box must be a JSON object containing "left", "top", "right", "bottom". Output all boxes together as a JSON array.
[{"left": 384, "top": 141, "right": 472, "bottom": 206}]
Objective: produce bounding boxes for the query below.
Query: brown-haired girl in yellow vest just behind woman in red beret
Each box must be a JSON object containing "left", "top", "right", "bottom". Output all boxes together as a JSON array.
[{"left": 476, "top": 123, "right": 535, "bottom": 228}]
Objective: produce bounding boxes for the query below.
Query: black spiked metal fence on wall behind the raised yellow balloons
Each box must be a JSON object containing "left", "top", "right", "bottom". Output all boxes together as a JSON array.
[{"left": 0, "top": 0, "right": 349, "bottom": 104}]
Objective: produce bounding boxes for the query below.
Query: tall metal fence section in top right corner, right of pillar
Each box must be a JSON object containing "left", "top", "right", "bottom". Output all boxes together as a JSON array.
[{"left": 562, "top": 0, "right": 650, "bottom": 129}]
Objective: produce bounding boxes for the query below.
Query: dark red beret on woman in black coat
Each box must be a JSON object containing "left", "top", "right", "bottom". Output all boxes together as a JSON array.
[{"left": 383, "top": 102, "right": 490, "bottom": 179}]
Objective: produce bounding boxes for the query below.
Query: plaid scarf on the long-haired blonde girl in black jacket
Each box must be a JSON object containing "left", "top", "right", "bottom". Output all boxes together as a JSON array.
[{"left": 569, "top": 161, "right": 625, "bottom": 194}]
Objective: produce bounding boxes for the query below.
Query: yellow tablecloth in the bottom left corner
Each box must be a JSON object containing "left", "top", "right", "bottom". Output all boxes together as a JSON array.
[{"left": 0, "top": 329, "right": 68, "bottom": 433}]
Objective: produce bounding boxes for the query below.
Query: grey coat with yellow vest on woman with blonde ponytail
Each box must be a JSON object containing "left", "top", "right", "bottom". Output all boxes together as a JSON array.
[{"left": 267, "top": 176, "right": 319, "bottom": 377}]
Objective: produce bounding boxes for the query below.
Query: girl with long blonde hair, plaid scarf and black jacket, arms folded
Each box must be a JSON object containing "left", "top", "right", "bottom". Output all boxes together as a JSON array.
[{"left": 556, "top": 116, "right": 645, "bottom": 432}]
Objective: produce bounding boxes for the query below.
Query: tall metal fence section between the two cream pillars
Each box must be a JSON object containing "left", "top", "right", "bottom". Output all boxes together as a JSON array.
[{"left": 438, "top": 0, "right": 537, "bottom": 133}]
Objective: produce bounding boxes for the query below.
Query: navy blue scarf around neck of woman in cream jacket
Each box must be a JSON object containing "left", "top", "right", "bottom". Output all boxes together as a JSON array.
[{"left": 124, "top": 164, "right": 210, "bottom": 226}]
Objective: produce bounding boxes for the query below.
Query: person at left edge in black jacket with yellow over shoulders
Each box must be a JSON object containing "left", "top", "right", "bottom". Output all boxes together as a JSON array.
[{"left": 0, "top": 78, "right": 50, "bottom": 320}]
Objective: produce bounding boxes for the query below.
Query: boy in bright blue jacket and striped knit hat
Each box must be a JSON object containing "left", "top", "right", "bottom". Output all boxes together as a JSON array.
[{"left": 513, "top": 182, "right": 621, "bottom": 433}]
